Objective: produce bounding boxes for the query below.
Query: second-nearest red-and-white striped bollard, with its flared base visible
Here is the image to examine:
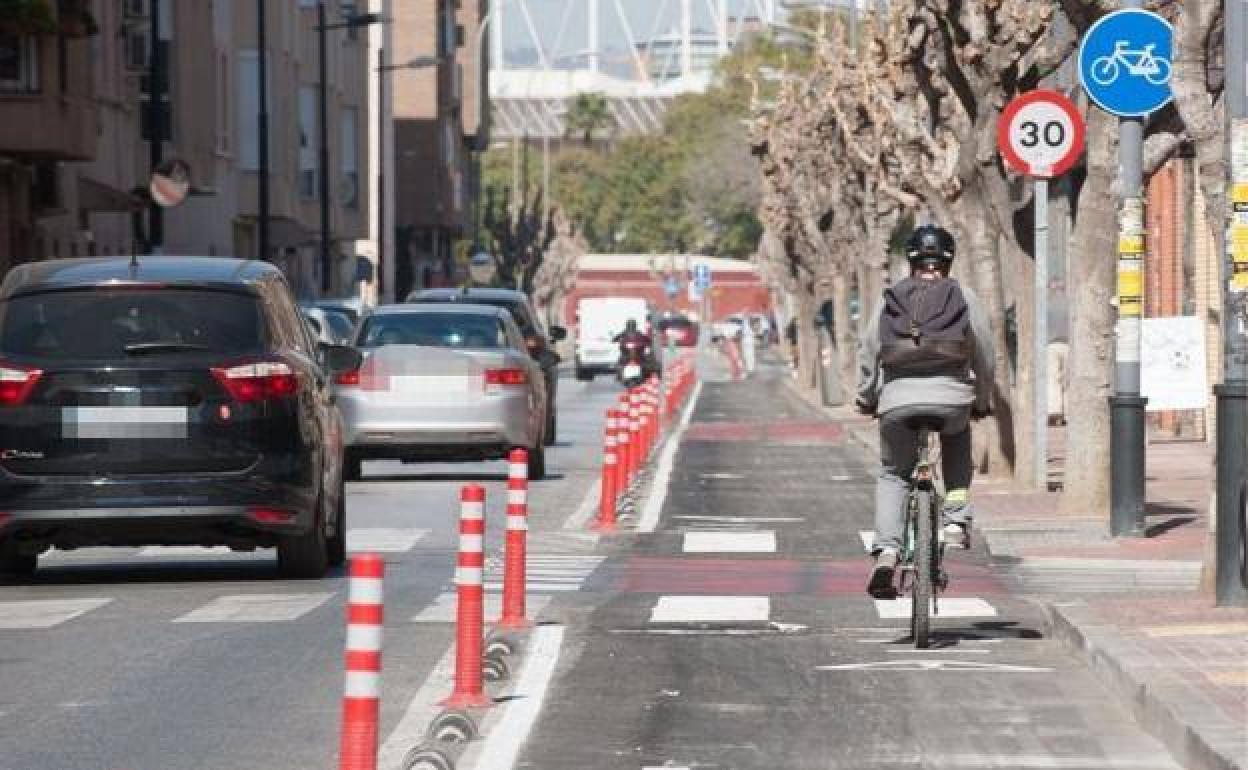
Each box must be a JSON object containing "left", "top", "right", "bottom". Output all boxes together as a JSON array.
[{"left": 442, "top": 484, "right": 490, "bottom": 709}]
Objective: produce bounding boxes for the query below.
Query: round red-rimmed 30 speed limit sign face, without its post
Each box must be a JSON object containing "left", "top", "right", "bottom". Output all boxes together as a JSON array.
[{"left": 997, "top": 90, "right": 1083, "bottom": 178}]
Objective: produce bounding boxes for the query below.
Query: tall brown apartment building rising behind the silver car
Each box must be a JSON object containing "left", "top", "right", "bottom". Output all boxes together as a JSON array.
[{"left": 388, "top": 0, "right": 488, "bottom": 298}]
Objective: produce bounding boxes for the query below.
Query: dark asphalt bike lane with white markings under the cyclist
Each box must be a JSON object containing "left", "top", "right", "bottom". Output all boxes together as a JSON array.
[{"left": 504, "top": 367, "right": 1177, "bottom": 770}]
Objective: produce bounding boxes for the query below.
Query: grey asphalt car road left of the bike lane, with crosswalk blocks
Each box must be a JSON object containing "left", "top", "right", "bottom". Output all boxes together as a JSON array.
[{"left": 0, "top": 371, "right": 618, "bottom": 770}]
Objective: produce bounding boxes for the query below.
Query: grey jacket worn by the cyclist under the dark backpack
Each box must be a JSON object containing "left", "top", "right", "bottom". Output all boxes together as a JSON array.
[{"left": 857, "top": 285, "right": 996, "bottom": 414}]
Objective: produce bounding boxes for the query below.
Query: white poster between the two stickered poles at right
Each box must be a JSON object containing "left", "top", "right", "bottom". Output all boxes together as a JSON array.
[{"left": 1139, "top": 316, "right": 1209, "bottom": 412}]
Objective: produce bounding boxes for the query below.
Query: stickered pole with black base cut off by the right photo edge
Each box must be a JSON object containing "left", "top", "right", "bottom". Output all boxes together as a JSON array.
[{"left": 1214, "top": 0, "right": 1248, "bottom": 607}]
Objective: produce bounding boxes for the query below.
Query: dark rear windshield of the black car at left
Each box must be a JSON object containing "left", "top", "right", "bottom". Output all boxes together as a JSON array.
[{"left": 0, "top": 287, "right": 265, "bottom": 359}]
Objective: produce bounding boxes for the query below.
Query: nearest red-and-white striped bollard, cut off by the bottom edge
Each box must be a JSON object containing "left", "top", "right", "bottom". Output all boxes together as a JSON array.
[{"left": 338, "top": 553, "right": 386, "bottom": 770}]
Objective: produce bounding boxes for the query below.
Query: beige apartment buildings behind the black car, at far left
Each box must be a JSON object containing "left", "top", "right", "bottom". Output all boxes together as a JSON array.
[{"left": 0, "top": 0, "right": 372, "bottom": 296}]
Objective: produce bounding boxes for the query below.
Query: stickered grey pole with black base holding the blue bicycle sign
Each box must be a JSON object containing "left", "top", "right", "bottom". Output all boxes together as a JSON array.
[{"left": 1113, "top": 0, "right": 1148, "bottom": 537}]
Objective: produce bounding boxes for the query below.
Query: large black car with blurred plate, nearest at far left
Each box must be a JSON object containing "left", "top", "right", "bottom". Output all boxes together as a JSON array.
[{"left": 0, "top": 257, "right": 359, "bottom": 578}]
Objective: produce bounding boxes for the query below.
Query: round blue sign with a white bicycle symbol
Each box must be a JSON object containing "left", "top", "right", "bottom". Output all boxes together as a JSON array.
[{"left": 1080, "top": 9, "right": 1174, "bottom": 117}]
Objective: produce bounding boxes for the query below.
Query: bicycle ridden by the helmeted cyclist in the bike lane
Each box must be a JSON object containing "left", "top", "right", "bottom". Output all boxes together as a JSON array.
[{"left": 897, "top": 417, "right": 948, "bottom": 649}]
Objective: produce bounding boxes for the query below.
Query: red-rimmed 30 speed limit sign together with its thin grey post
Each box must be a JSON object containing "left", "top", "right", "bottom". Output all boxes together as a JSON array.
[{"left": 997, "top": 90, "right": 1085, "bottom": 489}]
